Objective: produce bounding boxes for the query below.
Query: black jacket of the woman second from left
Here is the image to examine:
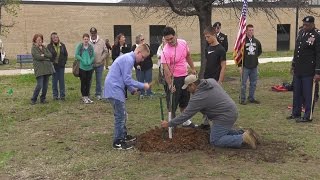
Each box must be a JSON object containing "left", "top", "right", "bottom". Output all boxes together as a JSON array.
[{"left": 47, "top": 42, "right": 68, "bottom": 67}]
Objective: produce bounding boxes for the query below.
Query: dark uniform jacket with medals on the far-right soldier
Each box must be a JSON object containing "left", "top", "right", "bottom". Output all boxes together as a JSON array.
[{"left": 292, "top": 29, "right": 320, "bottom": 76}]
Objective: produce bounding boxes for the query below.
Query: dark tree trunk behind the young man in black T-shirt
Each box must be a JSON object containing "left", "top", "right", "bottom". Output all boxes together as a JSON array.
[{"left": 198, "top": 6, "right": 212, "bottom": 79}]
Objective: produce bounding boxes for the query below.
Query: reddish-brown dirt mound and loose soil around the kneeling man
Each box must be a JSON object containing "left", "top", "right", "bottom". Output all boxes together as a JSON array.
[{"left": 135, "top": 127, "right": 295, "bottom": 163}]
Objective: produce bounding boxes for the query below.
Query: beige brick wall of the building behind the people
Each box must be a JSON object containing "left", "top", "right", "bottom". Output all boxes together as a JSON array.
[{"left": 2, "top": 4, "right": 320, "bottom": 58}]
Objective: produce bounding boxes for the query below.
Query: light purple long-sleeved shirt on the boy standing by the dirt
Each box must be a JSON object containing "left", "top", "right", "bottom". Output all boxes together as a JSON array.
[{"left": 103, "top": 52, "right": 144, "bottom": 102}]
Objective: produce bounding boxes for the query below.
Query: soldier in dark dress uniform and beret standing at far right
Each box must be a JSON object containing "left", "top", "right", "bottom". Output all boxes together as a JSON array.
[{"left": 287, "top": 16, "right": 320, "bottom": 122}]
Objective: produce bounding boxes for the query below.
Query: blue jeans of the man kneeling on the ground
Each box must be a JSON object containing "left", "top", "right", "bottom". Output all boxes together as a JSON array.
[{"left": 210, "top": 125, "right": 243, "bottom": 148}]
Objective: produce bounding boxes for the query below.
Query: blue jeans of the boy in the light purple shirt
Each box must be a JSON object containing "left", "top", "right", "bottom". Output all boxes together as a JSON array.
[{"left": 108, "top": 98, "right": 127, "bottom": 143}]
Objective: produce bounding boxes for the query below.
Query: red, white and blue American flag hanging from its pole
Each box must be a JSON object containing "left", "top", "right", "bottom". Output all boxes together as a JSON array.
[{"left": 233, "top": 0, "right": 248, "bottom": 65}]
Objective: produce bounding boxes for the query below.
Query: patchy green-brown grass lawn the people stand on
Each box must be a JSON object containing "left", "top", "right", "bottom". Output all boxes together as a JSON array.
[{"left": 0, "top": 63, "right": 320, "bottom": 180}]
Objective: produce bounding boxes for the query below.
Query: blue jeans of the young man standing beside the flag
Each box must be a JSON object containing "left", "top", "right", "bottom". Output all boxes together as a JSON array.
[{"left": 240, "top": 67, "right": 258, "bottom": 102}]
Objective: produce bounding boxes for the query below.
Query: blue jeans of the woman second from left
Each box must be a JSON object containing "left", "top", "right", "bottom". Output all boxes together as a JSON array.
[{"left": 52, "top": 66, "right": 66, "bottom": 98}]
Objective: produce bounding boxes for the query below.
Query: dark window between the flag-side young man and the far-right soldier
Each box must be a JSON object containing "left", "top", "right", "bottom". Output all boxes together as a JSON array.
[{"left": 277, "top": 24, "right": 290, "bottom": 51}]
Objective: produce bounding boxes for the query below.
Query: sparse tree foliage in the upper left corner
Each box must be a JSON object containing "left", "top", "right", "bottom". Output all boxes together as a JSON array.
[{"left": 0, "top": 0, "right": 20, "bottom": 35}]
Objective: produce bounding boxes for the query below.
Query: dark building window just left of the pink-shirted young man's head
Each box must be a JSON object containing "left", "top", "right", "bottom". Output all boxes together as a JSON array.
[{"left": 149, "top": 25, "right": 166, "bottom": 54}]
